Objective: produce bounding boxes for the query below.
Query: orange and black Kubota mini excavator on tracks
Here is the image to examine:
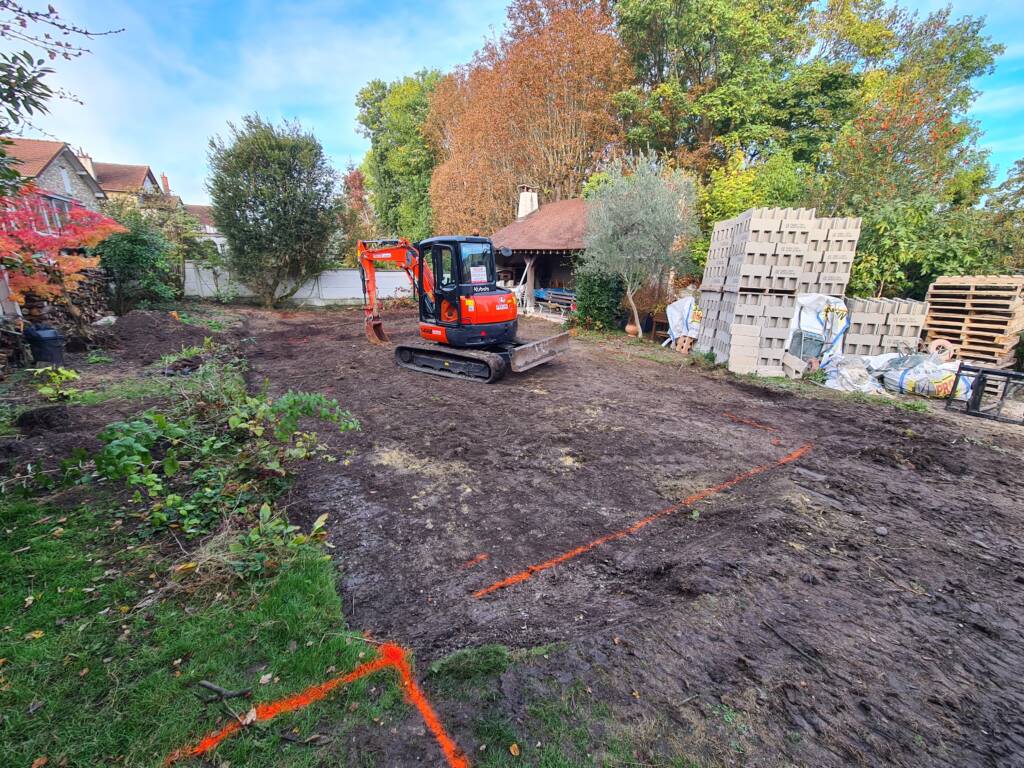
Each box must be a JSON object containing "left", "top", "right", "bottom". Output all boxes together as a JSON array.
[{"left": 358, "top": 236, "right": 568, "bottom": 383}]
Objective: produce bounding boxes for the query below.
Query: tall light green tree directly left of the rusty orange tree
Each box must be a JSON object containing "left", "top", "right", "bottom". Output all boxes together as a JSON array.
[{"left": 355, "top": 70, "right": 441, "bottom": 240}]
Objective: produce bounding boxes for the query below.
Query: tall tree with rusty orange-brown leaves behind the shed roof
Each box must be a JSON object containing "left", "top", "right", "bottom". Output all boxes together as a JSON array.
[{"left": 424, "top": 0, "right": 629, "bottom": 232}]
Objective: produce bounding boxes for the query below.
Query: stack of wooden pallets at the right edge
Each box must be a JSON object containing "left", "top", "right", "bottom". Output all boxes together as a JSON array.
[{"left": 925, "top": 274, "right": 1024, "bottom": 369}]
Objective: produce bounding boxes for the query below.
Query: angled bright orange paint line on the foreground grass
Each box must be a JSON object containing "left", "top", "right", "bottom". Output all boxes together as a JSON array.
[{"left": 164, "top": 643, "right": 469, "bottom": 768}]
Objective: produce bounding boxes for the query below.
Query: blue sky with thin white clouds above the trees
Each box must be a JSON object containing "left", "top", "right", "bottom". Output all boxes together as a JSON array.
[{"left": 8, "top": 0, "right": 1024, "bottom": 203}]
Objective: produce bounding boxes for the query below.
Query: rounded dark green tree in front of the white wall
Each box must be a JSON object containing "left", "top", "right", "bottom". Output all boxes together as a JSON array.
[{"left": 207, "top": 115, "right": 341, "bottom": 307}]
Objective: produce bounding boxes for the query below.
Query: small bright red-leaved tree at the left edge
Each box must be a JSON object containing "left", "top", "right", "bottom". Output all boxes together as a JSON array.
[{"left": 0, "top": 186, "right": 124, "bottom": 304}]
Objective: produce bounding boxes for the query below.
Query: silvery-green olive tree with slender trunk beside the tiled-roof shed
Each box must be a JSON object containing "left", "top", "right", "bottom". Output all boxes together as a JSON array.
[{"left": 580, "top": 154, "right": 697, "bottom": 336}]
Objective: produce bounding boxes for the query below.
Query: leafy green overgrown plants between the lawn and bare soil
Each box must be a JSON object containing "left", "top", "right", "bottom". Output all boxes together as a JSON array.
[{"left": 95, "top": 360, "right": 358, "bottom": 552}]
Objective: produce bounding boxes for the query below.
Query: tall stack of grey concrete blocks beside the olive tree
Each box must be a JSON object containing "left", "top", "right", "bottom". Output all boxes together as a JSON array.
[{"left": 696, "top": 208, "right": 860, "bottom": 376}]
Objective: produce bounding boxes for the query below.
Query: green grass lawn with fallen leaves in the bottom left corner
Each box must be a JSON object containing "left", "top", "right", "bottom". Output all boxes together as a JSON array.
[{"left": 0, "top": 501, "right": 404, "bottom": 768}]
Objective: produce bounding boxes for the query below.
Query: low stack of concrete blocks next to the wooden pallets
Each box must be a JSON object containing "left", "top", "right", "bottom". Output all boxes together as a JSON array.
[{"left": 843, "top": 299, "right": 928, "bottom": 355}]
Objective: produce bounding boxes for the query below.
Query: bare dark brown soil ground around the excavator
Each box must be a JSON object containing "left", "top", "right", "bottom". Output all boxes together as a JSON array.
[{"left": 216, "top": 310, "right": 1024, "bottom": 766}]
